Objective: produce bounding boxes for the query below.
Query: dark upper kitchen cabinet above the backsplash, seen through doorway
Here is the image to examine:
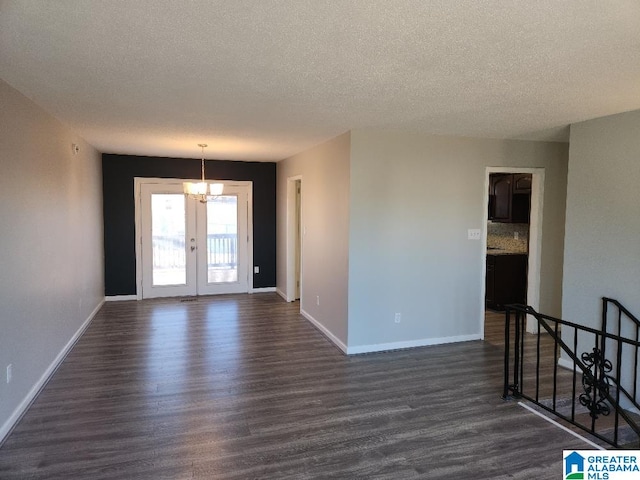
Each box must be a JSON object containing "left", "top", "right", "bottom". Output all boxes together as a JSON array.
[{"left": 489, "top": 173, "right": 531, "bottom": 223}]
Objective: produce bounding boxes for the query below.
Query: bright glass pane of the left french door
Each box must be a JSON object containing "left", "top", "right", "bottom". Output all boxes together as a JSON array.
[{"left": 151, "top": 193, "right": 187, "bottom": 286}]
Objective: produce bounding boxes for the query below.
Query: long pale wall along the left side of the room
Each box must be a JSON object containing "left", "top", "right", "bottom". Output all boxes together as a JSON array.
[{"left": 0, "top": 80, "right": 104, "bottom": 441}]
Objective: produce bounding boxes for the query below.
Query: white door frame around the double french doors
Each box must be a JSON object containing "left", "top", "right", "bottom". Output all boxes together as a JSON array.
[{"left": 133, "top": 177, "right": 253, "bottom": 300}]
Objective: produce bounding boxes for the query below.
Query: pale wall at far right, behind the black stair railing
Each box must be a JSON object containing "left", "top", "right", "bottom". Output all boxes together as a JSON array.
[{"left": 562, "top": 111, "right": 640, "bottom": 327}]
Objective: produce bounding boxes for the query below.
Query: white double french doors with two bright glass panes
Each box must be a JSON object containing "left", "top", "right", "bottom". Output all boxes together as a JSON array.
[{"left": 138, "top": 181, "right": 251, "bottom": 298}]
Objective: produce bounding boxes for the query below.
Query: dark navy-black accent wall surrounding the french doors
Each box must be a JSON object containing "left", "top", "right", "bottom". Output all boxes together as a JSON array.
[{"left": 102, "top": 154, "right": 276, "bottom": 296}]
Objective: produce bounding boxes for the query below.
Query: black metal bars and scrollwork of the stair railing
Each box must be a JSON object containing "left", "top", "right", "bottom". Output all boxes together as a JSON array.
[{"left": 503, "top": 299, "right": 640, "bottom": 447}]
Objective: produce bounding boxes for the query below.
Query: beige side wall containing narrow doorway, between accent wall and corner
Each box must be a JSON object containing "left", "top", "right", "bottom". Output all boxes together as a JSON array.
[{"left": 276, "top": 133, "right": 350, "bottom": 350}]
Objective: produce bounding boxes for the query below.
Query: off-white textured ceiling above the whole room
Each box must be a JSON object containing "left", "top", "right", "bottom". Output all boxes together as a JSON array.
[{"left": 0, "top": 0, "right": 640, "bottom": 160}]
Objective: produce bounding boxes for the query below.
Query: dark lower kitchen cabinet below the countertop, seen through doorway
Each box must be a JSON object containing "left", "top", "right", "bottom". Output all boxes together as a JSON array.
[{"left": 485, "top": 254, "right": 527, "bottom": 310}]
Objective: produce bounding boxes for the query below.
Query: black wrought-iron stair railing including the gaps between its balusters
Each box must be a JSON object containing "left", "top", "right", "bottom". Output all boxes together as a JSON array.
[{"left": 503, "top": 299, "right": 640, "bottom": 447}]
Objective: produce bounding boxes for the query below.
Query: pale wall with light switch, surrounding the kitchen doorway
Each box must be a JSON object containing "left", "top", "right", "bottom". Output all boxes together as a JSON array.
[{"left": 348, "top": 130, "right": 567, "bottom": 353}]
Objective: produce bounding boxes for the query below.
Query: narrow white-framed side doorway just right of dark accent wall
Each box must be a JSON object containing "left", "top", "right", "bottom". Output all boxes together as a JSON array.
[{"left": 285, "top": 175, "right": 304, "bottom": 305}]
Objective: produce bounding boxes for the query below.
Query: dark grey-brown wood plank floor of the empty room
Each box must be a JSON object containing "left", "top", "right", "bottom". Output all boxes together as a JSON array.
[{"left": 0, "top": 294, "right": 587, "bottom": 480}]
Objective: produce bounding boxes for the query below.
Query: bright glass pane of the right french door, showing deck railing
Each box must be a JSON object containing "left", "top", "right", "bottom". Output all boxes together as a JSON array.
[{"left": 207, "top": 195, "right": 238, "bottom": 283}]
